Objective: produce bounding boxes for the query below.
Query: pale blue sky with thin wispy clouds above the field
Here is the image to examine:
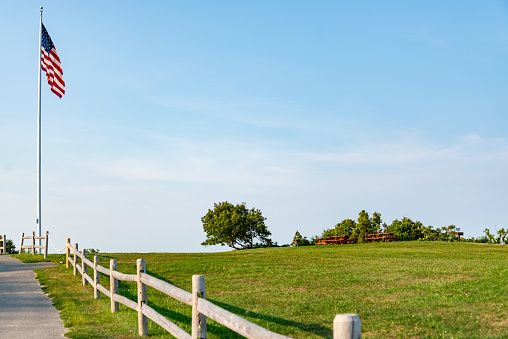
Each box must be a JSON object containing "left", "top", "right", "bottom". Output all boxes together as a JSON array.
[{"left": 0, "top": 0, "right": 508, "bottom": 253}]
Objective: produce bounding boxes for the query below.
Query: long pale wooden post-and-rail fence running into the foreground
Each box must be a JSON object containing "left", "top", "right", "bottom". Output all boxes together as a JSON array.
[{"left": 65, "top": 239, "right": 361, "bottom": 339}]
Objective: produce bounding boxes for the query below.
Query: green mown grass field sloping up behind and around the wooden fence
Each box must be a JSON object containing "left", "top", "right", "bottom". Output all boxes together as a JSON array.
[{"left": 18, "top": 241, "right": 508, "bottom": 338}]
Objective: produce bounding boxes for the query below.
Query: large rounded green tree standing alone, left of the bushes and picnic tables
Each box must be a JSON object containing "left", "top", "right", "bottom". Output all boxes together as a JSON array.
[{"left": 201, "top": 201, "right": 272, "bottom": 250}]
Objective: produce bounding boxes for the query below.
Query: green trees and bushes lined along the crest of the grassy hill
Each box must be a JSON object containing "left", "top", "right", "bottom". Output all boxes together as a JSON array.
[{"left": 201, "top": 201, "right": 508, "bottom": 249}]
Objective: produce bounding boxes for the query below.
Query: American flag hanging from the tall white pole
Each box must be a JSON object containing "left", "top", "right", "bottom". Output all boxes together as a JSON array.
[{"left": 41, "top": 25, "right": 65, "bottom": 98}]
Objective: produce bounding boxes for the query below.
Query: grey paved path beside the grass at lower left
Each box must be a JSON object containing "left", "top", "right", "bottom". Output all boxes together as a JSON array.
[{"left": 0, "top": 255, "right": 66, "bottom": 339}]
